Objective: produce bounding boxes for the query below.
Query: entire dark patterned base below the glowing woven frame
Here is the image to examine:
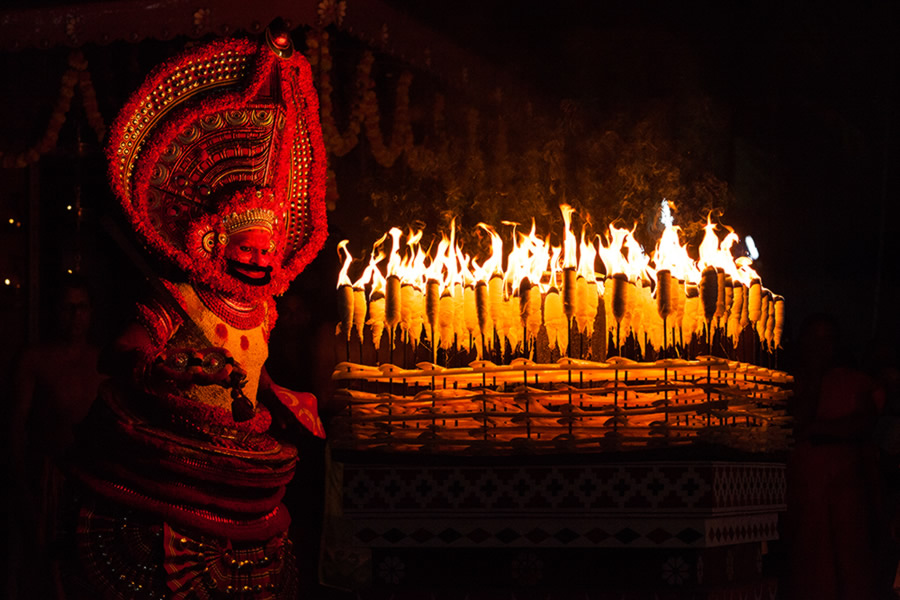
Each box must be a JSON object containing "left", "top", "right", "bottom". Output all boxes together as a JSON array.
[{"left": 325, "top": 461, "right": 785, "bottom": 588}]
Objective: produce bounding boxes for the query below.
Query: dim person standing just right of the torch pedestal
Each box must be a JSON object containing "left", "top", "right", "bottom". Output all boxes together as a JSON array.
[{"left": 787, "top": 316, "right": 878, "bottom": 600}]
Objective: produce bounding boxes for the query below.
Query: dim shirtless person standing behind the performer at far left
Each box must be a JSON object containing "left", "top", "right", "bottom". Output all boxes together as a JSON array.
[{"left": 9, "top": 276, "right": 103, "bottom": 598}]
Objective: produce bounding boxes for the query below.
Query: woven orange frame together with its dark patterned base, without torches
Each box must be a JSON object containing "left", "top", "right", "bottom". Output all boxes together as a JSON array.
[{"left": 323, "top": 358, "right": 790, "bottom": 598}]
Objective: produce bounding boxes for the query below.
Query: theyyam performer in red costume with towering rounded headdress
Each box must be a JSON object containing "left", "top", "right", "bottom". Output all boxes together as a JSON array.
[{"left": 69, "top": 24, "right": 326, "bottom": 599}]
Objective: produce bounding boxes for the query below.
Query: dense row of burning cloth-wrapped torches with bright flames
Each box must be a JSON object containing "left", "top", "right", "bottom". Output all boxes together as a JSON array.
[{"left": 337, "top": 205, "right": 784, "bottom": 362}]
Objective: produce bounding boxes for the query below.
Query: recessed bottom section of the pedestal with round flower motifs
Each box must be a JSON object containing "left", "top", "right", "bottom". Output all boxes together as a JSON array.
[{"left": 326, "top": 544, "right": 774, "bottom": 599}]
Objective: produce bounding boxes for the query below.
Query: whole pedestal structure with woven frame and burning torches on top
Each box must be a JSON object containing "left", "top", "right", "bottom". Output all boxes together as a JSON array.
[{"left": 322, "top": 202, "right": 791, "bottom": 599}]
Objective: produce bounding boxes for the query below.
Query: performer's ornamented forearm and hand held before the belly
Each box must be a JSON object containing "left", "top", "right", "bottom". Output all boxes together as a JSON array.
[{"left": 154, "top": 348, "right": 247, "bottom": 387}]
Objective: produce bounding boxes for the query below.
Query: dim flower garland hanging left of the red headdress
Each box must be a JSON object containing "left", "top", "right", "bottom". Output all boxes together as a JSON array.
[{"left": 0, "top": 50, "right": 106, "bottom": 169}]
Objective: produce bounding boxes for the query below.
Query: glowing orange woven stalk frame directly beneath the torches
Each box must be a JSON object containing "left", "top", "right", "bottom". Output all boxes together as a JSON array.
[{"left": 332, "top": 356, "right": 790, "bottom": 454}]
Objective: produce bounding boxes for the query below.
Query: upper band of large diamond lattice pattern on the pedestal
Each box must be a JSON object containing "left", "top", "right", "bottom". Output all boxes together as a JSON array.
[{"left": 343, "top": 462, "right": 785, "bottom": 515}]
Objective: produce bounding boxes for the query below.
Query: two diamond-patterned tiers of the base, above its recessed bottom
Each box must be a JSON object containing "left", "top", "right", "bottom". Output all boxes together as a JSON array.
[{"left": 342, "top": 462, "right": 785, "bottom": 548}]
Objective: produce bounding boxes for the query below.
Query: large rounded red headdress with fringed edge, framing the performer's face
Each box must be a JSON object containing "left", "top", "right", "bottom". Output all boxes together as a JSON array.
[{"left": 108, "top": 32, "right": 327, "bottom": 294}]
